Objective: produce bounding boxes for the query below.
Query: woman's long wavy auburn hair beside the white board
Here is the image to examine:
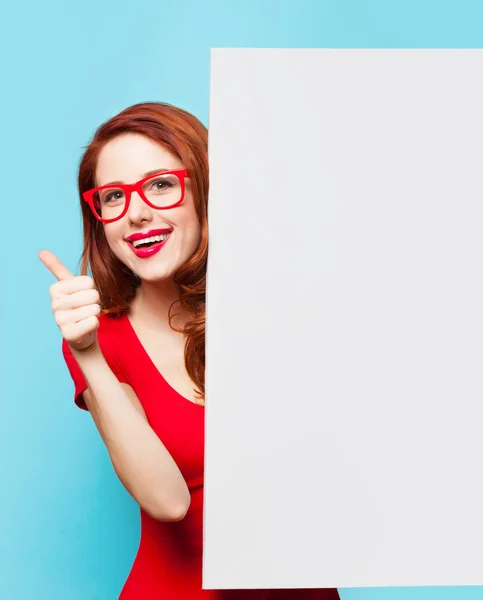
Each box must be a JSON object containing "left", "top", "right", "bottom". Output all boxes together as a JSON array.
[{"left": 78, "top": 102, "right": 209, "bottom": 404}]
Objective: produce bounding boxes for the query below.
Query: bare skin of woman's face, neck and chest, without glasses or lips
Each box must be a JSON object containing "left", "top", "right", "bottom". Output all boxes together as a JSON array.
[{"left": 96, "top": 133, "right": 201, "bottom": 402}]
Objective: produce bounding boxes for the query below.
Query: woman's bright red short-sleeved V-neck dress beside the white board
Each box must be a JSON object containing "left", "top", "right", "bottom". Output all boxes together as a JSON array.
[{"left": 62, "top": 315, "right": 339, "bottom": 600}]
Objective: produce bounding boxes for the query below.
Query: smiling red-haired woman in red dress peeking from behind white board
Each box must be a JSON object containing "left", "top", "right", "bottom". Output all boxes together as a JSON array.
[{"left": 39, "top": 103, "right": 339, "bottom": 600}]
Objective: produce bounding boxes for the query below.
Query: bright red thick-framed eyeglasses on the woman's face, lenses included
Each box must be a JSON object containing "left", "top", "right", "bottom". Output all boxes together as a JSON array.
[{"left": 82, "top": 169, "right": 188, "bottom": 223}]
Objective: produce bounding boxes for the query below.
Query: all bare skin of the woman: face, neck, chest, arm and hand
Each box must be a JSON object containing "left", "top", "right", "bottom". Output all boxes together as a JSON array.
[{"left": 39, "top": 133, "right": 205, "bottom": 521}]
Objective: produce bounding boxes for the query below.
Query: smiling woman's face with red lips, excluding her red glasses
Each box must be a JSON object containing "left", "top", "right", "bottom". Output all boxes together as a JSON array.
[{"left": 95, "top": 133, "right": 201, "bottom": 282}]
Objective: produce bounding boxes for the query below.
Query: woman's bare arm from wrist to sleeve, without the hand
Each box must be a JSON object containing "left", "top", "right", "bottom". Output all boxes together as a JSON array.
[{"left": 72, "top": 344, "right": 191, "bottom": 521}]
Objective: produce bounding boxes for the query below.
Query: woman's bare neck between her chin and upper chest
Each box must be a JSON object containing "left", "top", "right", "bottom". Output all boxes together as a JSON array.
[{"left": 130, "top": 279, "right": 189, "bottom": 327}]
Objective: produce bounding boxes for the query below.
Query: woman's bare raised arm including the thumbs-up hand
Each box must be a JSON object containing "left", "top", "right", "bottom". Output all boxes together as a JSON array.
[{"left": 39, "top": 250, "right": 191, "bottom": 521}]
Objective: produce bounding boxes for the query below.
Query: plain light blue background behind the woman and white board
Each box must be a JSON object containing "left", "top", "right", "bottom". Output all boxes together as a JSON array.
[{"left": 0, "top": 0, "right": 483, "bottom": 600}]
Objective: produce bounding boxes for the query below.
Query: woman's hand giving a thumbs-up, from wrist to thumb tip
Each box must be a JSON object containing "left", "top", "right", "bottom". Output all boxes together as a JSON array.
[{"left": 38, "top": 250, "right": 101, "bottom": 351}]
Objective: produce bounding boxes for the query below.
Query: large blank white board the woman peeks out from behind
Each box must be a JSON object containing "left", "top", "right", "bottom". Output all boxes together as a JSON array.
[{"left": 203, "top": 49, "right": 483, "bottom": 588}]
